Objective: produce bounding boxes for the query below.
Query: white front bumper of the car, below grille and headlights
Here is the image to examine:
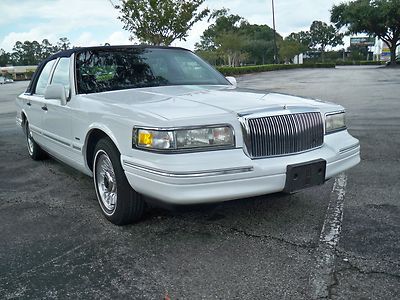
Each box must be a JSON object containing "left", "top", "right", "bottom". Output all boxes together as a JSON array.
[{"left": 121, "top": 131, "right": 360, "bottom": 204}]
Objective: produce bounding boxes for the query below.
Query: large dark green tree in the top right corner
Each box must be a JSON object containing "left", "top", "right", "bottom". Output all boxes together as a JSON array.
[{"left": 331, "top": 0, "right": 400, "bottom": 64}]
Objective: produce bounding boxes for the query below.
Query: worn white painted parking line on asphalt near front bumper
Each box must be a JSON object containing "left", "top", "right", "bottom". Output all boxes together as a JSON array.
[{"left": 310, "top": 173, "right": 347, "bottom": 299}]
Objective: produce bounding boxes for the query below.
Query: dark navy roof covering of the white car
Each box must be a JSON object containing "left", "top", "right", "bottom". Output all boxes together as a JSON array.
[{"left": 26, "top": 45, "right": 190, "bottom": 94}]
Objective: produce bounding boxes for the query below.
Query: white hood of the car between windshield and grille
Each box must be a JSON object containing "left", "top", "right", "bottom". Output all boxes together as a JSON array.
[{"left": 85, "top": 85, "right": 338, "bottom": 120}]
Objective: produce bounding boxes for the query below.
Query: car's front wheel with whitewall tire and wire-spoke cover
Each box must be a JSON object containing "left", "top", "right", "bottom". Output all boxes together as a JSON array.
[{"left": 93, "top": 138, "right": 145, "bottom": 225}]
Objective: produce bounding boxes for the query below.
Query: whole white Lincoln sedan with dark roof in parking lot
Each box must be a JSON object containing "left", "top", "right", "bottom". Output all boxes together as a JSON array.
[{"left": 17, "top": 46, "right": 360, "bottom": 225}]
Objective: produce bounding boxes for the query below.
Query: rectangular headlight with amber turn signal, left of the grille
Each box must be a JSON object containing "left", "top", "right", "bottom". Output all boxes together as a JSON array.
[{"left": 132, "top": 125, "right": 235, "bottom": 151}]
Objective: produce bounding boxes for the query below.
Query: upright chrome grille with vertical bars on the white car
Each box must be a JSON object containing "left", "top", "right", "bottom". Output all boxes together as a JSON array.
[{"left": 242, "top": 112, "right": 324, "bottom": 158}]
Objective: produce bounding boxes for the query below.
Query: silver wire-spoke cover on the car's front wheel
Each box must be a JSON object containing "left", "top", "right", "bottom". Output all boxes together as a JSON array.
[{"left": 94, "top": 150, "right": 118, "bottom": 215}]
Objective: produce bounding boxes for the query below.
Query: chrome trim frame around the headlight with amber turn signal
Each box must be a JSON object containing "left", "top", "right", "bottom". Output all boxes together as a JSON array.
[{"left": 132, "top": 123, "right": 236, "bottom": 154}]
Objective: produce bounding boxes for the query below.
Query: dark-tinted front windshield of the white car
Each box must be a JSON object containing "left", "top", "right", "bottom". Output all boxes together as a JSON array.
[{"left": 76, "top": 48, "right": 229, "bottom": 94}]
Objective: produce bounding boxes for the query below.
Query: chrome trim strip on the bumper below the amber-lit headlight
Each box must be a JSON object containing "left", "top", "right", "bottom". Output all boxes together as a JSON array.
[{"left": 123, "top": 160, "right": 254, "bottom": 178}]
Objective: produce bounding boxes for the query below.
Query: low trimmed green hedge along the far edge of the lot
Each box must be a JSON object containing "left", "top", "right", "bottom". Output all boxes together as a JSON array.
[{"left": 217, "top": 63, "right": 335, "bottom": 76}]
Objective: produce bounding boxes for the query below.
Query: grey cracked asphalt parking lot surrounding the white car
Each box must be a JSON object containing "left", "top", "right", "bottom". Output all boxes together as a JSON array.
[{"left": 0, "top": 67, "right": 400, "bottom": 299}]
